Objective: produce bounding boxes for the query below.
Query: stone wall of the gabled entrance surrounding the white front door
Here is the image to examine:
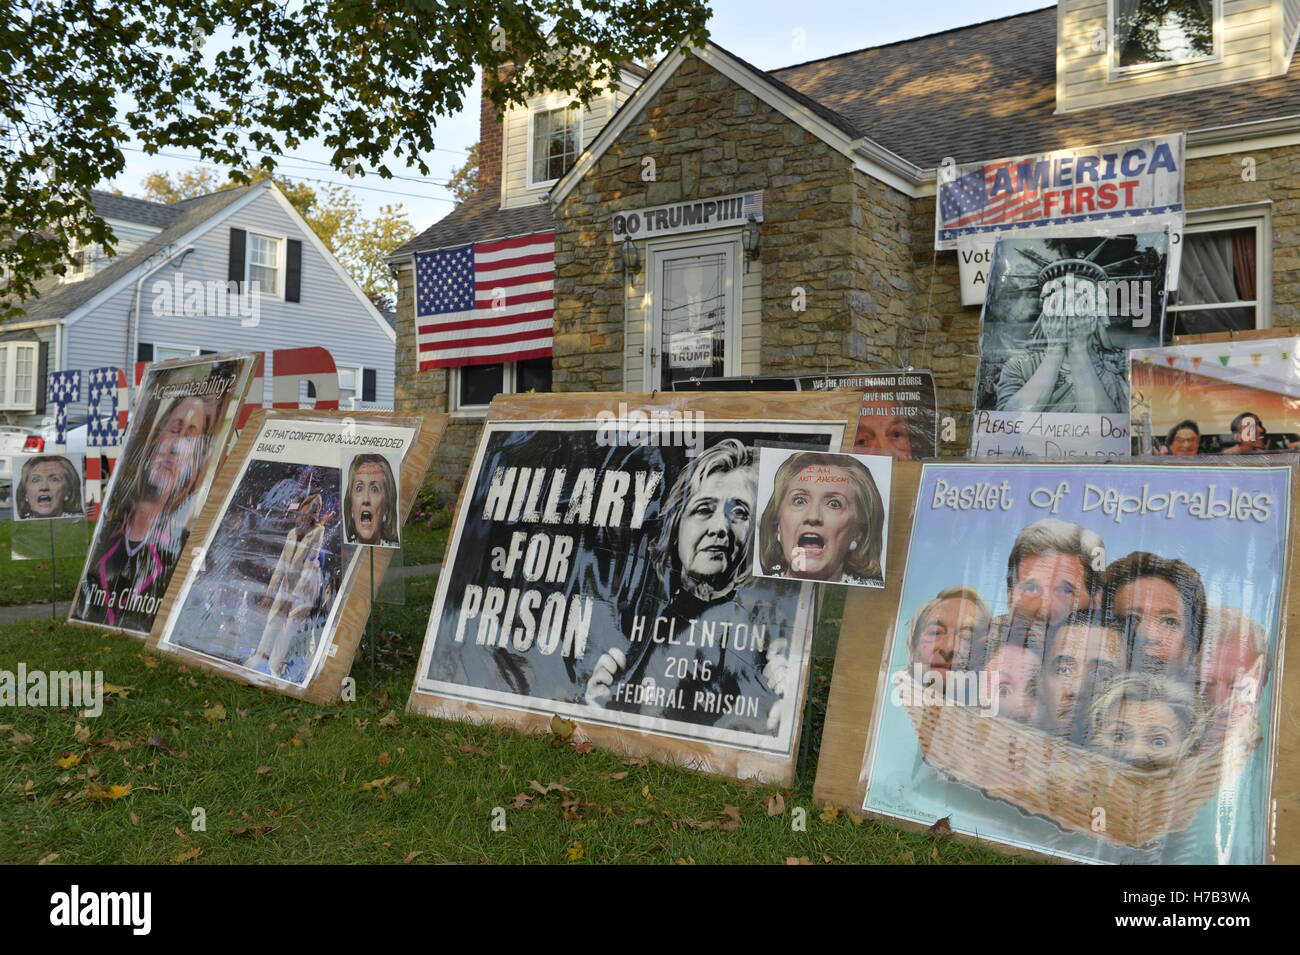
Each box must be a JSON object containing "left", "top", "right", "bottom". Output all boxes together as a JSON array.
[{"left": 555, "top": 57, "right": 909, "bottom": 391}]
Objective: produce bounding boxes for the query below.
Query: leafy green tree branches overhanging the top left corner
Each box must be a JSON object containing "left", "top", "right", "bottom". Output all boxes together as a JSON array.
[{"left": 0, "top": 0, "right": 709, "bottom": 318}]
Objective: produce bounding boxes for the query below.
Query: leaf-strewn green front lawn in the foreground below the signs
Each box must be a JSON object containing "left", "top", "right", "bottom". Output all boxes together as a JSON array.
[{"left": 0, "top": 578, "right": 1006, "bottom": 864}]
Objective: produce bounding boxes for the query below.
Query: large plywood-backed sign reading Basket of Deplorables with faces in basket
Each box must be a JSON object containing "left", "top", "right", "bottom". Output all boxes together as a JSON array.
[{"left": 814, "top": 461, "right": 1300, "bottom": 864}]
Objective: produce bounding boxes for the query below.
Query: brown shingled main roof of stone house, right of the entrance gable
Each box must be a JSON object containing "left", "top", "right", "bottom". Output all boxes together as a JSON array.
[{"left": 772, "top": 6, "right": 1300, "bottom": 169}]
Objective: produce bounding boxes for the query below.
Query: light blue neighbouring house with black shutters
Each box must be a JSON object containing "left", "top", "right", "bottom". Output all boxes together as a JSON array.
[{"left": 0, "top": 182, "right": 395, "bottom": 426}]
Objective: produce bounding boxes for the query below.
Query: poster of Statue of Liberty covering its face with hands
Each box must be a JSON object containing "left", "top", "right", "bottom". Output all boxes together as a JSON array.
[{"left": 970, "top": 233, "right": 1169, "bottom": 459}]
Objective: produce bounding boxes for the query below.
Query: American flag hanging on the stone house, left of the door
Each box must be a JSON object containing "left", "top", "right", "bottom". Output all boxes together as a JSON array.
[{"left": 415, "top": 233, "right": 555, "bottom": 369}]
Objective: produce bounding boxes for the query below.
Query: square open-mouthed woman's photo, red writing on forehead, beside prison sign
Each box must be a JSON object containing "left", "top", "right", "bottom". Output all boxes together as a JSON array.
[{"left": 754, "top": 447, "right": 893, "bottom": 587}]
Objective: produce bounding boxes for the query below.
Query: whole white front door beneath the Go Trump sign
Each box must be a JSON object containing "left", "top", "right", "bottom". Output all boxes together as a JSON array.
[{"left": 645, "top": 242, "right": 740, "bottom": 391}]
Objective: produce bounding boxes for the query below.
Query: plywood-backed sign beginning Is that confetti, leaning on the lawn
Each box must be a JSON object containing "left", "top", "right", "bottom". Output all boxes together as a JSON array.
[{"left": 150, "top": 409, "right": 447, "bottom": 703}]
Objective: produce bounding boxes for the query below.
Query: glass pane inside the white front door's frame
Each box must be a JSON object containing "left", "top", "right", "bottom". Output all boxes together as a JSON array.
[{"left": 659, "top": 252, "right": 727, "bottom": 391}]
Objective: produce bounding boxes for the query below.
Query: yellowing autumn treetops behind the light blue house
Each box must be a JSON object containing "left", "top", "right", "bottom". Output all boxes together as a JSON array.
[{"left": 140, "top": 166, "right": 415, "bottom": 309}]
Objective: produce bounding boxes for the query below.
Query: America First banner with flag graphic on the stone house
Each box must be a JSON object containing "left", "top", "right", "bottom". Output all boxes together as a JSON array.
[{"left": 935, "top": 133, "right": 1184, "bottom": 251}]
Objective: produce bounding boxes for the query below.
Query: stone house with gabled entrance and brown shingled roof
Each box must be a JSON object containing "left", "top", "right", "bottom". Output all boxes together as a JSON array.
[{"left": 395, "top": 0, "right": 1300, "bottom": 490}]
